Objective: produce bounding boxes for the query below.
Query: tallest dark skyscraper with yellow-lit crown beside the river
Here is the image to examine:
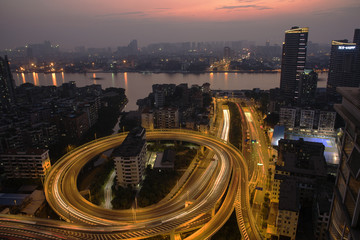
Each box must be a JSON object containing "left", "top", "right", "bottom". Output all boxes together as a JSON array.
[{"left": 280, "top": 27, "right": 309, "bottom": 102}]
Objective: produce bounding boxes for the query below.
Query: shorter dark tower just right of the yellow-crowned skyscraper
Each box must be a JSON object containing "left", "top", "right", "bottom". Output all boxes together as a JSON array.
[{"left": 298, "top": 69, "right": 318, "bottom": 106}]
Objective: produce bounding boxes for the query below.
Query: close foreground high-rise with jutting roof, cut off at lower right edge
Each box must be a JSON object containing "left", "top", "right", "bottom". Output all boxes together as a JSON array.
[{"left": 329, "top": 87, "right": 360, "bottom": 240}]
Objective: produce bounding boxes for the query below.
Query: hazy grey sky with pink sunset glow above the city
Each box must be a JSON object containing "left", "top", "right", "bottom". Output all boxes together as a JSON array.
[{"left": 0, "top": 0, "right": 360, "bottom": 49}]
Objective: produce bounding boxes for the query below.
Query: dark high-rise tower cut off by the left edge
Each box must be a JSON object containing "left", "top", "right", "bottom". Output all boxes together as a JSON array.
[{"left": 0, "top": 56, "right": 15, "bottom": 111}]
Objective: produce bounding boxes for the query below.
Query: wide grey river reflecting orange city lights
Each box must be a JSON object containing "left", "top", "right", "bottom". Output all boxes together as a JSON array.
[{"left": 13, "top": 72, "right": 327, "bottom": 111}]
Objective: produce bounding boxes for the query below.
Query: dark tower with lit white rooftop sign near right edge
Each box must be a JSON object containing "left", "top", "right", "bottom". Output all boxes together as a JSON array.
[{"left": 327, "top": 29, "right": 360, "bottom": 96}]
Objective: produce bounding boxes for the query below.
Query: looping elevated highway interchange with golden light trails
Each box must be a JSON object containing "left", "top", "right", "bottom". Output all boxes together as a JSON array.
[{"left": 0, "top": 104, "right": 260, "bottom": 239}]
